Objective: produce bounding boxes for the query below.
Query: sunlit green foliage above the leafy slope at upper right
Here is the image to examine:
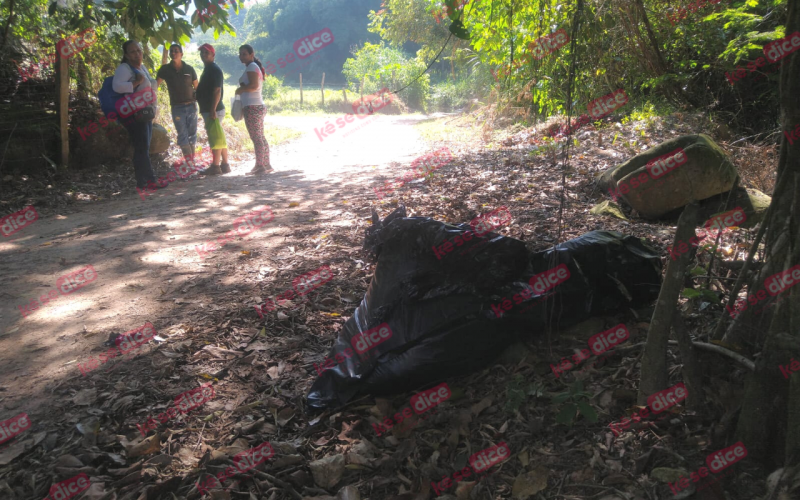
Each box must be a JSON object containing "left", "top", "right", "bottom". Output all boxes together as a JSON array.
[{"left": 406, "top": 0, "right": 786, "bottom": 133}]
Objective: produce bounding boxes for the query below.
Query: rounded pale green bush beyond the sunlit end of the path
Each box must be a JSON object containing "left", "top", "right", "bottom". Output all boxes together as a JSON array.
[{"left": 342, "top": 43, "right": 430, "bottom": 110}]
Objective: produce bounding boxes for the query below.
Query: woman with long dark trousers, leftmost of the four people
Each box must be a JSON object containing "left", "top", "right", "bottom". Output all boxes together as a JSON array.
[{"left": 112, "top": 40, "right": 162, "bottom": 190}]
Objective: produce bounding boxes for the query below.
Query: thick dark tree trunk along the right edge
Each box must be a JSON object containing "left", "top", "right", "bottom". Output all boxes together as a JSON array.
[{"left": 726, "top": 2, "right": 800, "bottom": 466}]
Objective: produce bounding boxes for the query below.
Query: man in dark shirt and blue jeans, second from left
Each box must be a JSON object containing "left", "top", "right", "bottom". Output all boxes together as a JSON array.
[{"left": 156, "top": 43, "right": 197, "bottom": 167}]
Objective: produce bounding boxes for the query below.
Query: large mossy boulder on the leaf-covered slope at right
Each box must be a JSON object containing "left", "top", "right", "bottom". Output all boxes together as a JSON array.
[{"left": 600, "top": 134, "right": 738, "bottom": 218}]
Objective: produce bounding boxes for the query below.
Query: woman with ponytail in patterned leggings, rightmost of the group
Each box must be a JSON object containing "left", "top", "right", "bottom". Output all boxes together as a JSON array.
[{"left": 236, "top": 45, "right": 272, "bottom": 175}]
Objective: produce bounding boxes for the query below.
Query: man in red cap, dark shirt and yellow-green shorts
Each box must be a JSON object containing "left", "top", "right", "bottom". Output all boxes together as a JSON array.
[{"left": 197, "top": 43, "right": 231, "bottom": 175}]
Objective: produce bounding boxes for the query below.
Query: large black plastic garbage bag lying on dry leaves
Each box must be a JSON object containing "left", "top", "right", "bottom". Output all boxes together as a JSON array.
[{"left": 308, "top": 207, "right": 661, "bottom": 409}]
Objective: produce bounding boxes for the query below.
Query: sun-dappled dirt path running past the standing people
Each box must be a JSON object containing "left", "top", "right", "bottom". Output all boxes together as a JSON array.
[{"left": 0, "top": 115, "right": 429, "bottom": 425}]
